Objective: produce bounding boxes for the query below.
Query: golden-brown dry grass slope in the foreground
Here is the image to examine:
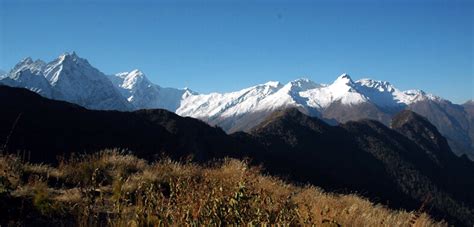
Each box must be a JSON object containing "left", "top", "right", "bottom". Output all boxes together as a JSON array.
[{"left": 0, "top": 150, "right": 446, "bottom": 226}]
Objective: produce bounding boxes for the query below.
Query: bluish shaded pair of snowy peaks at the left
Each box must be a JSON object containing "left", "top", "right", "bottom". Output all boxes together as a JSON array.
[{"left": 0, "top": 52, "right": 194, "bottom": 111}]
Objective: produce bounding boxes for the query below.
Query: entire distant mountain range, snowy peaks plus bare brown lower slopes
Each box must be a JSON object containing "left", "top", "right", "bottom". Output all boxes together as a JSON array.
[{"left": 0, "top": 52, "right": 474, "bottom": 158}]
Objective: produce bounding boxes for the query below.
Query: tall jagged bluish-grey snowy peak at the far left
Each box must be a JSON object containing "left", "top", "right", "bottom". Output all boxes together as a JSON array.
[{"left": 0, "top": 52, "right": 129, "bottom": 110}]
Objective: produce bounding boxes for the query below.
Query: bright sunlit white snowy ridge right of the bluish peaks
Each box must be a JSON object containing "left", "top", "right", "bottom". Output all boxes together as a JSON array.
[{"left": 176, "top": 74, "right": 440, "bottom": 118}]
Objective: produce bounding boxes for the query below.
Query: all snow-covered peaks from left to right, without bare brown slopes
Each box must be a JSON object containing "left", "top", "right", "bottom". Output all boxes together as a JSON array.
[{"left": 1, "top": 52, "right": 440, "bottom": 114}]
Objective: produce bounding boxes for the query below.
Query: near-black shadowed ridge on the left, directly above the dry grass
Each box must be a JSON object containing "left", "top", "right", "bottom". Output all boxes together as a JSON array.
[{"left": 0, "top": 86, "right": 244, "bottom": 162}]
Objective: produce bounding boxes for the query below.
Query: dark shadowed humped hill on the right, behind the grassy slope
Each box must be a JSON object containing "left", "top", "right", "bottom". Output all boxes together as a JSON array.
[{"left": 248, "top": 109, "right": 474, "bottom": 223}]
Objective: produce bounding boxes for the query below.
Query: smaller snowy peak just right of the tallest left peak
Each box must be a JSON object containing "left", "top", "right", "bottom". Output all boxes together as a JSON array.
[{"left": 109, "top": 69, "right": 196, "bottom": 112}]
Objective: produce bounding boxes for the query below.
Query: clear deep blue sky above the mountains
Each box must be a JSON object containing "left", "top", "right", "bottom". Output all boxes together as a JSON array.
[{"left": 0, "top": 0, "right": 474, "bottom": 103}]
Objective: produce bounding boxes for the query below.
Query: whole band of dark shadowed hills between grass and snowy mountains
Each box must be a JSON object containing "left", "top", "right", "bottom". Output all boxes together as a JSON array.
[{"left": 0, "top": 87, "right": 474, "bottom": 225}]
